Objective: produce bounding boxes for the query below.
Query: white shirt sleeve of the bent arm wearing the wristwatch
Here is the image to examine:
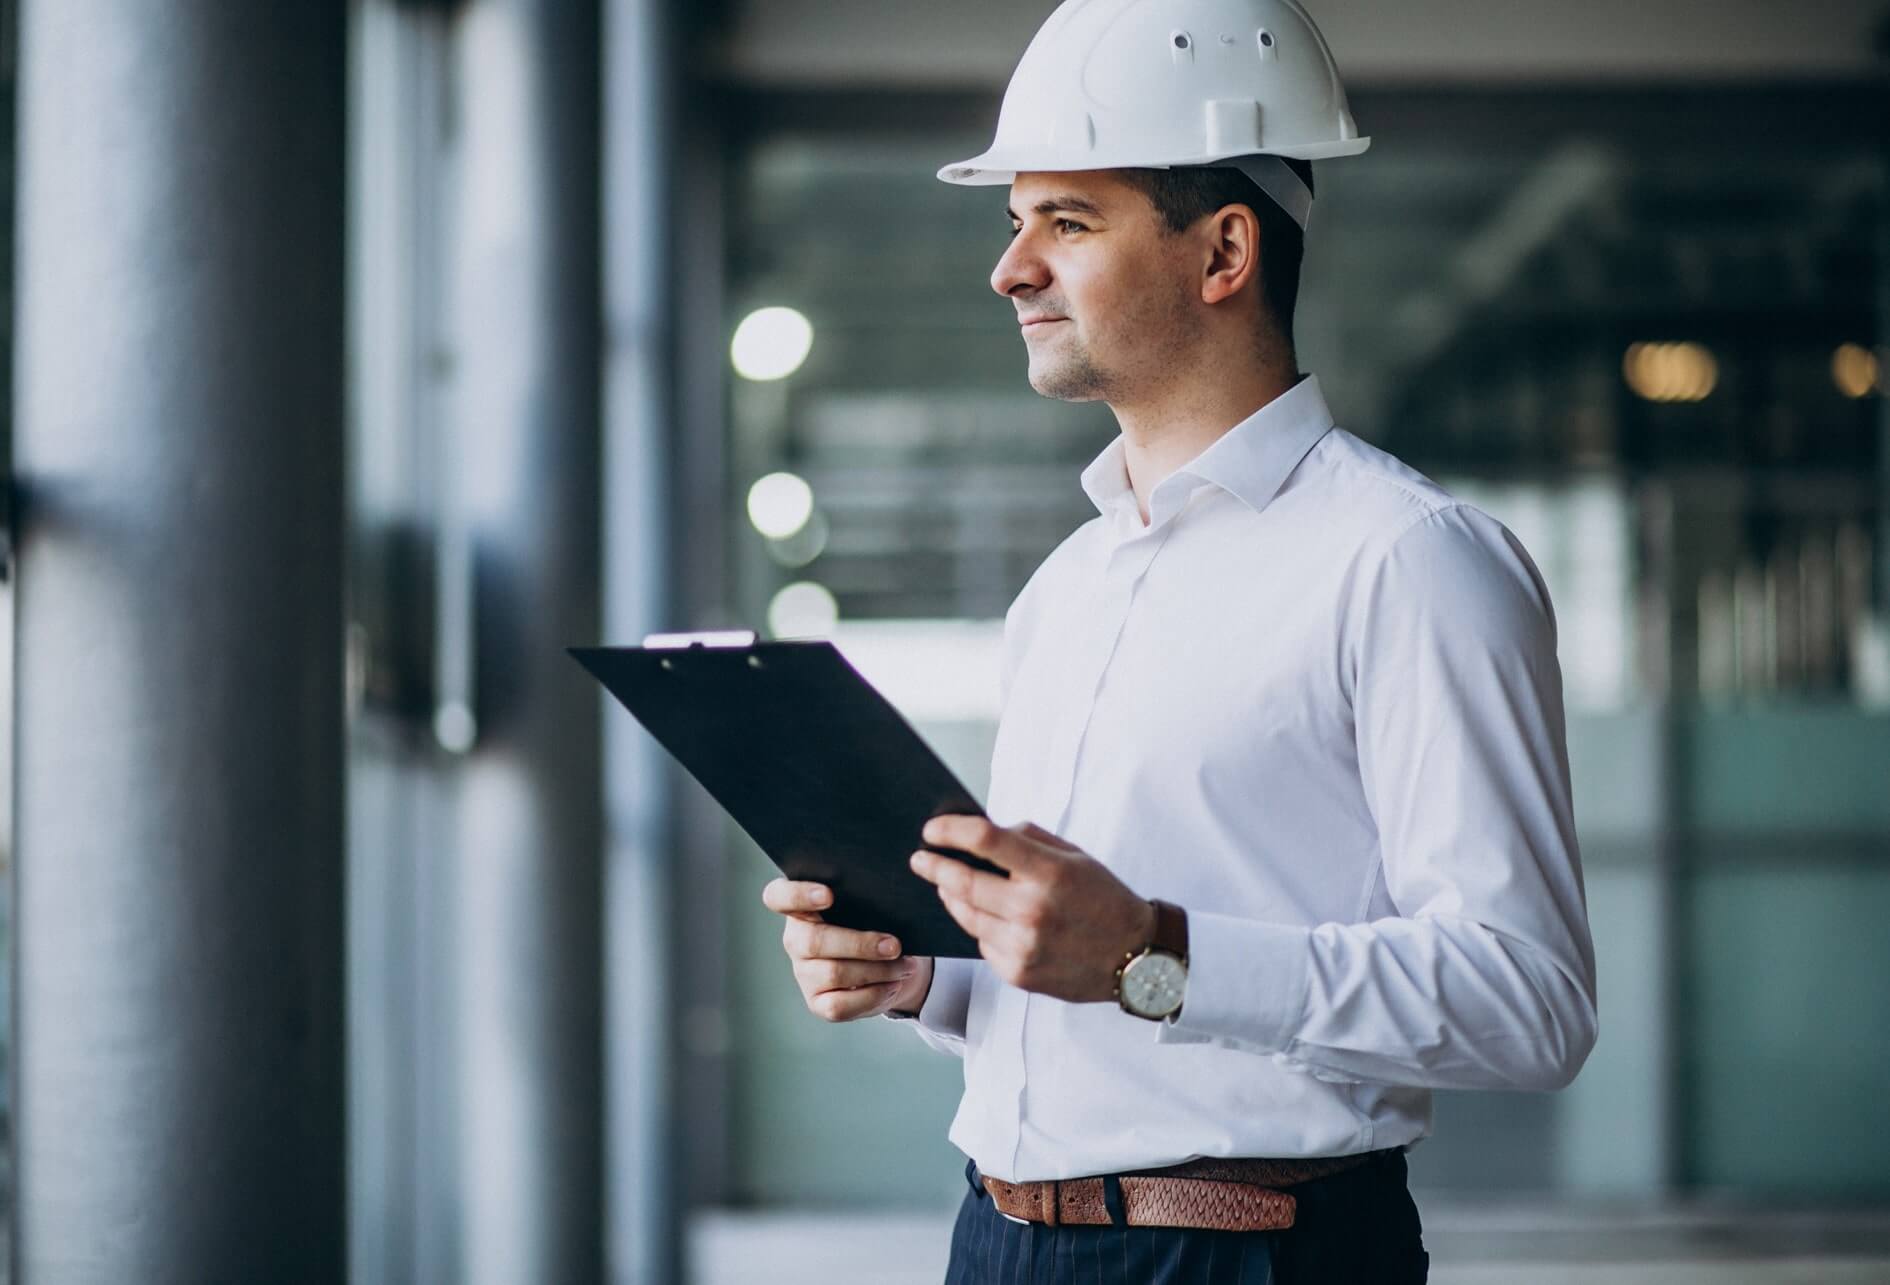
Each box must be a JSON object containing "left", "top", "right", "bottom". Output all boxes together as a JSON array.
[{"left": 1157, "top": 506, "right": 1595, "bottom": 1088}]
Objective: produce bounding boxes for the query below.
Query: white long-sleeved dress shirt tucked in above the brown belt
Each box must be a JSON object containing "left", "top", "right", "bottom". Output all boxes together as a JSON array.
[{"left": 884, "top": 376, "right": 1595, "bottom": 1181}]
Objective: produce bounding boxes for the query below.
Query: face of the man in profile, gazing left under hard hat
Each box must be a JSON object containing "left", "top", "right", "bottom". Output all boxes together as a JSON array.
[{"left": 990, "top": 170, "right": 1200, "bottom": 404}]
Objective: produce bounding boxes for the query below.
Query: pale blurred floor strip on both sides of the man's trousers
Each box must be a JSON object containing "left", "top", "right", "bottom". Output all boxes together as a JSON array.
[{"left": 690, "top": 1202, "right": 1890, "bottom": 1285}]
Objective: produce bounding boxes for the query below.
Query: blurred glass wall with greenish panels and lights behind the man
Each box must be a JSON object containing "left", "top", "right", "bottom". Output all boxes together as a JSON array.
[{"left": 724, "top": 89, "right": 1890, "bottom": 1206}]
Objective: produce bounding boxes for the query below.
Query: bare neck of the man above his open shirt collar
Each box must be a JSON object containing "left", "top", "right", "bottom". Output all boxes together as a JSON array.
[{"left": 1109, "top": 357, "right": 1300, "bottom": 525}]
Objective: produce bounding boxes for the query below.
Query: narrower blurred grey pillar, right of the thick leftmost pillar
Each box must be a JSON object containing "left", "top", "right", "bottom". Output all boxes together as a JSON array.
[{"left": 440, "top": 0, "right": 605, "bottom": 1285}]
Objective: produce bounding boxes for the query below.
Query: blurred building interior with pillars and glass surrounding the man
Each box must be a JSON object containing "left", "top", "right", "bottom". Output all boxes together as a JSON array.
[{"left": 0, "top": 0, "right": 1890, "bottom": 1285}]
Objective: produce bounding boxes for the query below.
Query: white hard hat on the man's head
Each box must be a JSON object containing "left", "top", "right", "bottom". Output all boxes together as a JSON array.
[{"left": 939, "top": 0, "right": 1372, "bottom": 225}]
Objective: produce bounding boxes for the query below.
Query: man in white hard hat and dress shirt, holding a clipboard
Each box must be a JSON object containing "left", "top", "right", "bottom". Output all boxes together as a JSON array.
[{"left": 764, "top": 0, "right": 1595, "bottom": 1283}]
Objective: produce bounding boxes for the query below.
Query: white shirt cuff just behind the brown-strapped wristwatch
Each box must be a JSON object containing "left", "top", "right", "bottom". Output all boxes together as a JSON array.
[{"left": 1155, "top": 911, "right": 1312, "bottom": 1053}]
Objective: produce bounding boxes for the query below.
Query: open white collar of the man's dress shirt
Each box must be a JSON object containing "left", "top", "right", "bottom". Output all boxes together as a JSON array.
[{"left": 1083, "top": 374, "right": 1332, "bottom": 529}]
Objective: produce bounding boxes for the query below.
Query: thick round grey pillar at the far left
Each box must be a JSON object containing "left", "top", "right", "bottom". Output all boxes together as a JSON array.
[{"left": 13, "top": 0, "right": 346, "bottom": 1281}]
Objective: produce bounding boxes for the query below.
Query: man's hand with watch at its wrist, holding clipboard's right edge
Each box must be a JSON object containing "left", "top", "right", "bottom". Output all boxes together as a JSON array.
[{"left": 911, "top": 816, "right": 1155, "bottom": 1003}]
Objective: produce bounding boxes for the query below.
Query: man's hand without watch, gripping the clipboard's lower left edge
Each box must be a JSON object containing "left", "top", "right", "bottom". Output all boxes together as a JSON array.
[{"left": 762, "top": 879, "right": 932, "bottom": 1022}]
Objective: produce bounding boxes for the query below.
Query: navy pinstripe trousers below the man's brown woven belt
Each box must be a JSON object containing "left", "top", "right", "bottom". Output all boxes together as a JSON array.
[{"left": 945, "top": 1151, "right": 1431, "bottom": 1285}]
